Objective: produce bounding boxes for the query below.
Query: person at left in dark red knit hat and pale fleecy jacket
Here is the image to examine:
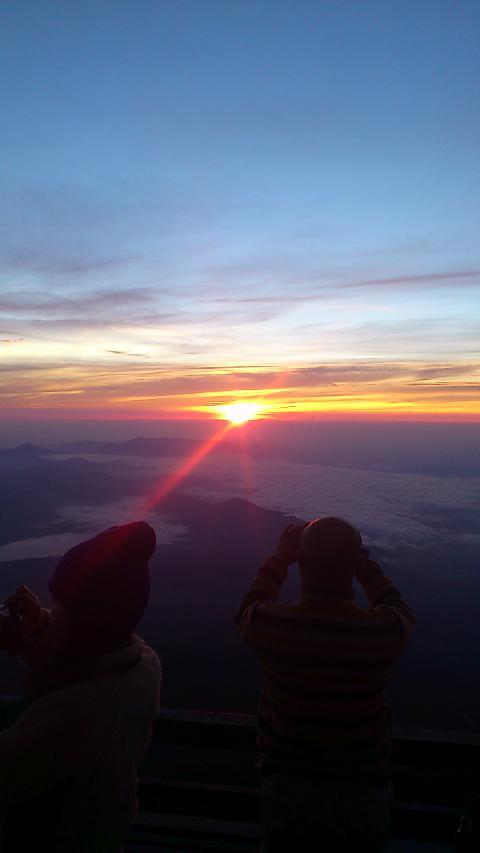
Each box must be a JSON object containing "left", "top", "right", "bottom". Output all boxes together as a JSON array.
[{"left": 0, "top": 521, "right": 161, "bottom": 853}]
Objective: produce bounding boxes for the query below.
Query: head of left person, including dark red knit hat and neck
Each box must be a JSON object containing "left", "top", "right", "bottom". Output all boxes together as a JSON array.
[{"left": 20, "top": 521, "right": 156, "bottom": 695}]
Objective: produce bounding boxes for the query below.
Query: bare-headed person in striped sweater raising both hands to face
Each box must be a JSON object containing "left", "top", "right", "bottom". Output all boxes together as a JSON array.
[{"left": 235, "top": 517, "right": 415, "bottom": 853}]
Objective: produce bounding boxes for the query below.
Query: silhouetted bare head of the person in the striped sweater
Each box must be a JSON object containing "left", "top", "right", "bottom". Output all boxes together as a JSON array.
[{"left": 298, "top": 516, "right": 362, "bottom": 595}]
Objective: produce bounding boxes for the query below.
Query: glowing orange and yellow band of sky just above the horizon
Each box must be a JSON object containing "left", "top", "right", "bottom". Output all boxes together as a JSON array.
[{"left": 0, "top": 360, "right": 480, "bottom": 421}]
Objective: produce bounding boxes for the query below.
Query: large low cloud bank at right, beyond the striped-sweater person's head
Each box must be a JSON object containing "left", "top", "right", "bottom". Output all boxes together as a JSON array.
[{"left": 172, "top": 452, "right": 480, "bottom": 553}]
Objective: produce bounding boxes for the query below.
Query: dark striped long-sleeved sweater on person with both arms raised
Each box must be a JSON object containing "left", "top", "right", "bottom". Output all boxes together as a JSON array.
[{"left": 235, "top": 557, "right": 415, "bottom": 777}]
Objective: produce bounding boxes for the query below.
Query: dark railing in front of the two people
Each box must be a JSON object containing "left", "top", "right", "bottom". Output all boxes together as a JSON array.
[{"left": 0, "top": 697, "right": 480, "bottom": 853}]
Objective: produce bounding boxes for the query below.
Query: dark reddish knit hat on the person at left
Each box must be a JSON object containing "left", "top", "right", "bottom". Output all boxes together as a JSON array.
[{"left": 48, "top": 521, "right": 156, "bottom": 652}]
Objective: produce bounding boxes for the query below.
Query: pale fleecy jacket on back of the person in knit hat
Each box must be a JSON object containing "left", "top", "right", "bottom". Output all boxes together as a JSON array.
[{"left": 0, "top": 636, "right": 160, "bottom": 853}]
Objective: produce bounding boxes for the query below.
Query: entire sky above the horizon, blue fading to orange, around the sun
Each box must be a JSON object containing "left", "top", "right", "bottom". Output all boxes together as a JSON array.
[{"left": 0, "top": 0, "right": 480, "bottom": 420}]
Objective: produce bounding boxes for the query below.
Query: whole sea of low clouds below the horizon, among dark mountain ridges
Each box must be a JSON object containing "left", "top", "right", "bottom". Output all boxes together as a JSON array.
[{"left": 0, "top": 454, "right": 480, "bottom": 561}]
